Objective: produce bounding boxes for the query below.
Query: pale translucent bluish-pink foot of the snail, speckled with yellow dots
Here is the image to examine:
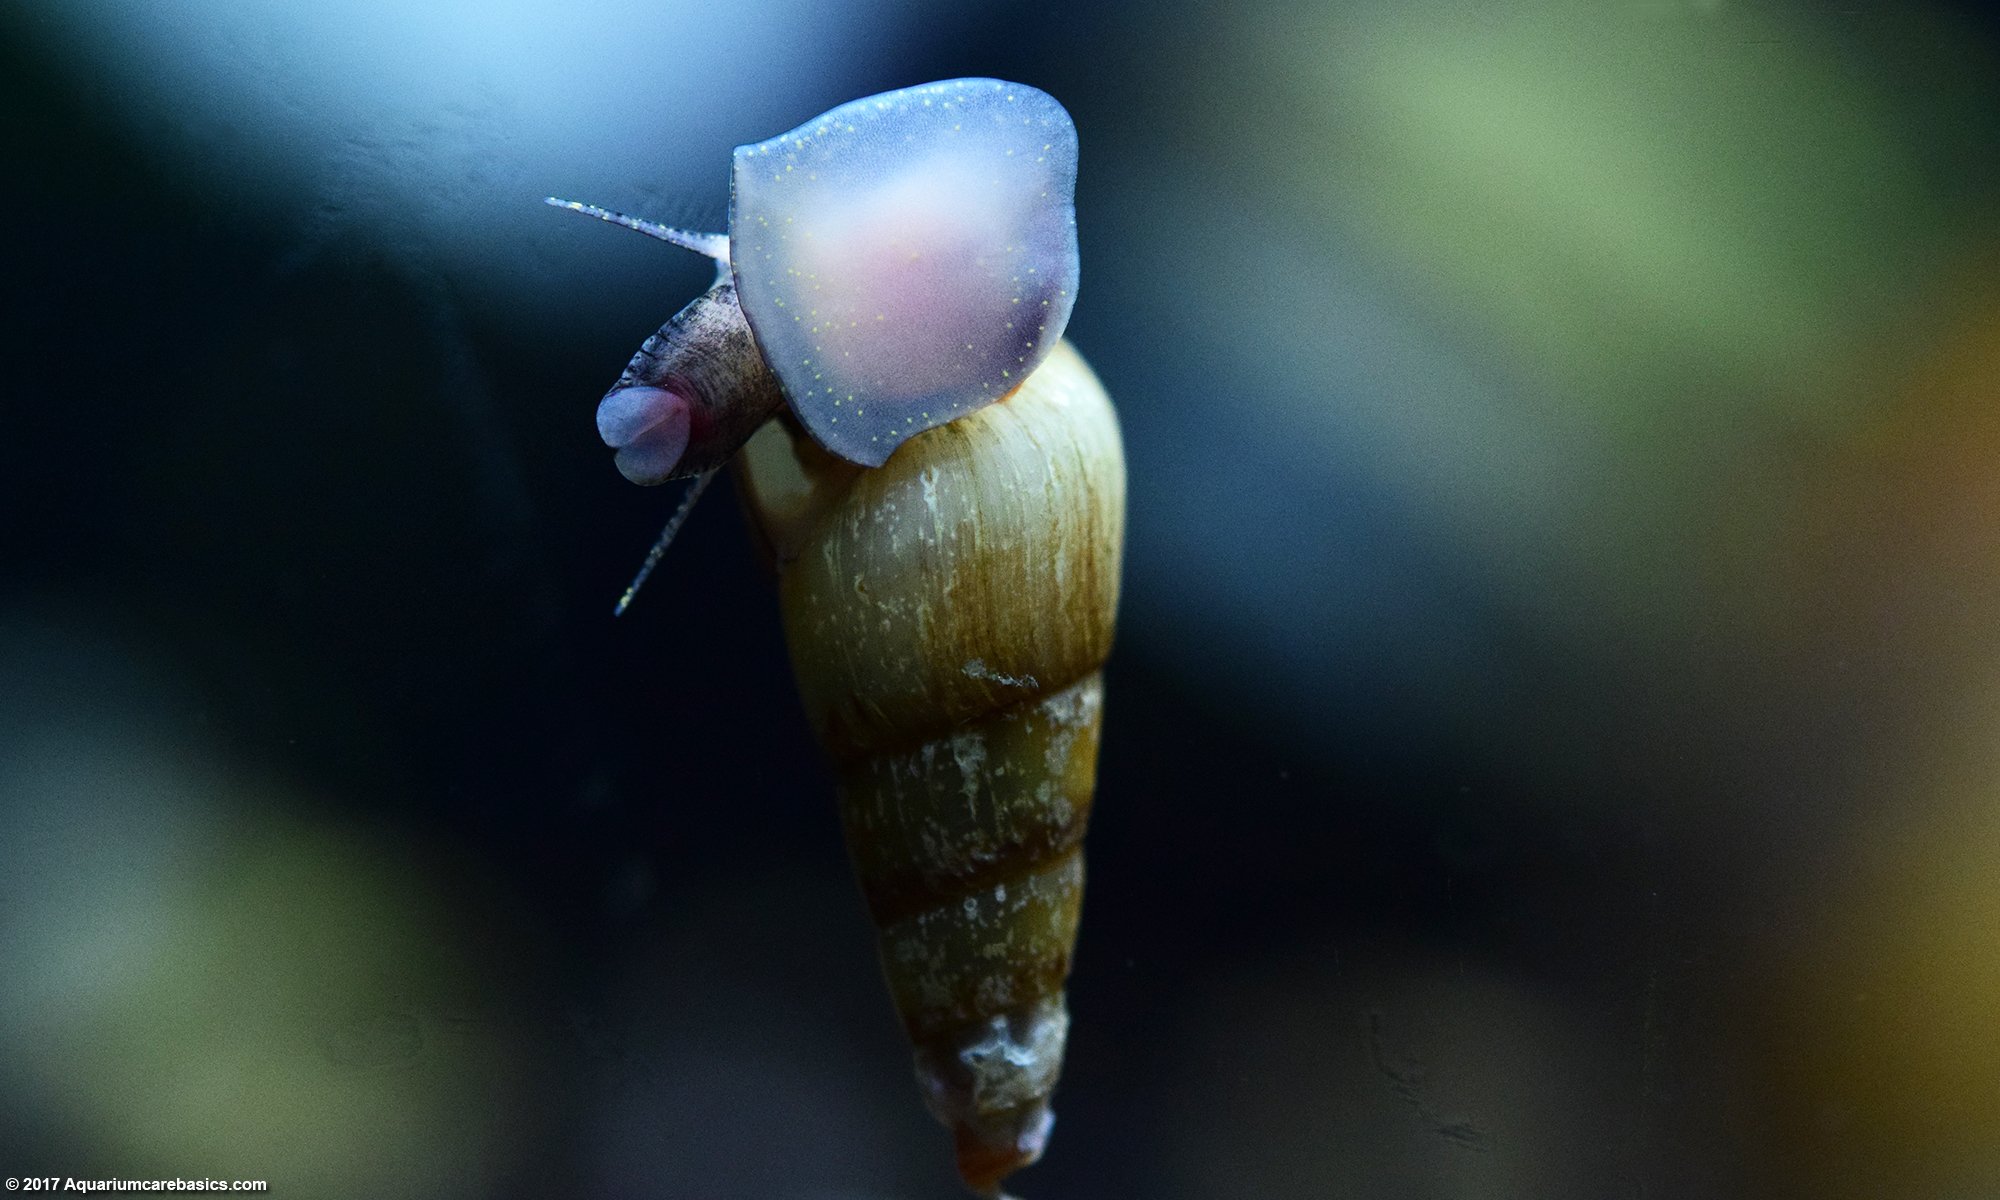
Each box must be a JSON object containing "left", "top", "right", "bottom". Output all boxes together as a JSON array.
[{"left": 730, "top": 80, "right": 1078, "bottom": 466}]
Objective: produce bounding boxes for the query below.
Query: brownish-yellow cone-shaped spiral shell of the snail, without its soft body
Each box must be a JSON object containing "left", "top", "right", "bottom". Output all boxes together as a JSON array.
[{"left": 738, "top": 342, "right": 1124, "bottom": 1194}]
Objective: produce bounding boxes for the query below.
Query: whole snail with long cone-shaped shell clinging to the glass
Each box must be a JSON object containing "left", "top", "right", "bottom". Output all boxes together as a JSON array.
[{"left": 556, "top": 80, "right": 1124, "bottom": 1196}]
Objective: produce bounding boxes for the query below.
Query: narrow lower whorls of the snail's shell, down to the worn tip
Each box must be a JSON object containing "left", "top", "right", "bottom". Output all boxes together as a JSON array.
[{"left": 840, "top": 674, "right": 1102, "bottom": 1190}]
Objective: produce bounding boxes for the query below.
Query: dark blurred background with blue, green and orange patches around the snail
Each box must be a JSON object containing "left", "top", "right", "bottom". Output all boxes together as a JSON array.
[{"left": 11, "top": 0, "right": 2000, "bottom": 1200}]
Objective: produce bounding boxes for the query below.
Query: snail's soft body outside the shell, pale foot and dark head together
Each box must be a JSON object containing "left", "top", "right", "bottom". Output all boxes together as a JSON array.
[{"left": 576, "top": 80, "right": 1078, "bottom": 484}]
